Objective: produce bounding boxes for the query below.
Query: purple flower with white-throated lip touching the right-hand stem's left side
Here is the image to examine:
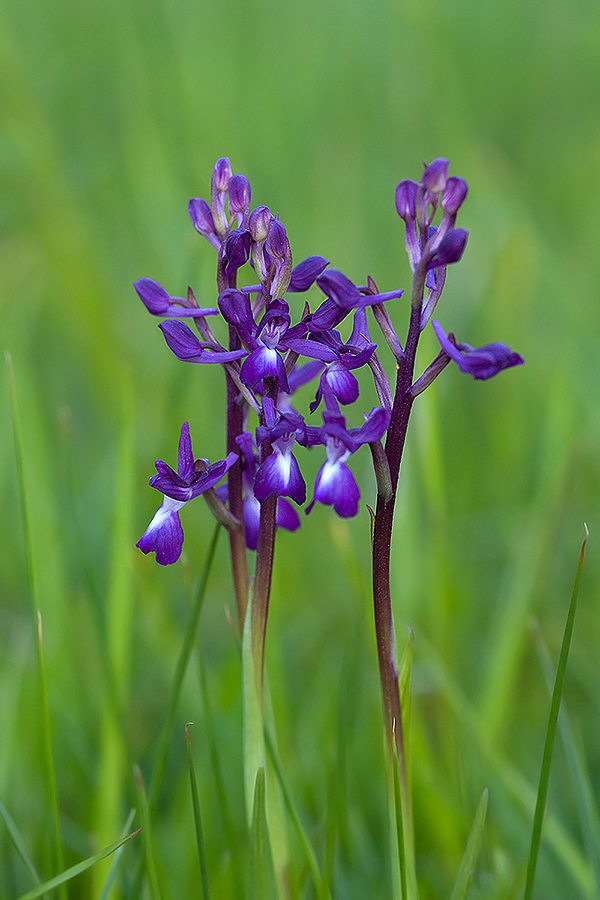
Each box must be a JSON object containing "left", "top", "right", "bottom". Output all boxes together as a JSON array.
[{"left": 306, "top": 406, "right": 390, "bottom": 519}]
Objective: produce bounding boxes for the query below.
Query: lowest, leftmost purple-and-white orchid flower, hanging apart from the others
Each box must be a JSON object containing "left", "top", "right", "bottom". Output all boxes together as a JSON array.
[{"left": 137, "top": 422, "right": 238, "bottom": 566}]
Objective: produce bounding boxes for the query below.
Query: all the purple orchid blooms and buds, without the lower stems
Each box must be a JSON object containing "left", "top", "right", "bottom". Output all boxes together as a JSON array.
[{"left": 135, "top": 158, "right": 523, "bottom": 565}]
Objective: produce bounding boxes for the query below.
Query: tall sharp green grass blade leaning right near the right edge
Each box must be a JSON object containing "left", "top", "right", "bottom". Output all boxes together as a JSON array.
[{"left": 524, "top": 527, "right": 588, "bottom": 900}]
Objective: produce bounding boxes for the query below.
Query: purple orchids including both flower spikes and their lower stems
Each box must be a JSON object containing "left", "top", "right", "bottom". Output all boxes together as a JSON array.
[{"left": 135, "top": 158, "right": 523, "bottom": 880}]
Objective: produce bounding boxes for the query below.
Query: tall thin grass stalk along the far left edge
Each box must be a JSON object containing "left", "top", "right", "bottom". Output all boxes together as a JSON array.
[{"left": 5, "top": 352, "right": 67, "bottom": 900}]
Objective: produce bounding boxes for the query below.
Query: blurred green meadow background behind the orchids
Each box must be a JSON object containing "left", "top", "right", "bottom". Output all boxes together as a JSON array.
[{"left": 0, "top": 0, "right": 600, "bottom": 900}]
